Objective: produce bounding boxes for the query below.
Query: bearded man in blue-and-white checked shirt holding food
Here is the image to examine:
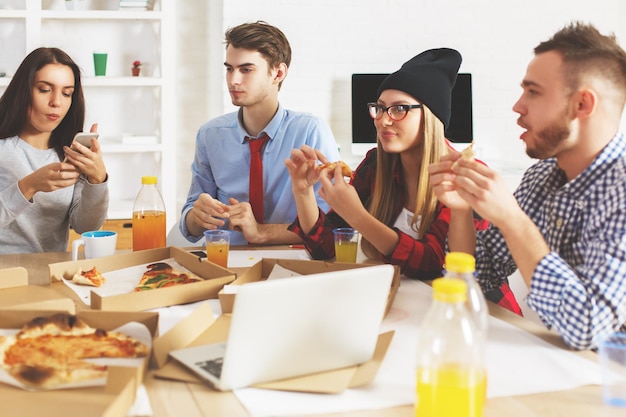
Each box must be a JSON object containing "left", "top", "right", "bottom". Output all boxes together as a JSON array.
[{"left": 430, "top": 23, "right": 626, "bottom": 349}]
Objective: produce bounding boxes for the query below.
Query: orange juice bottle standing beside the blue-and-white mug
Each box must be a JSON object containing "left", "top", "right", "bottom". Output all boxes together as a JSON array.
[{"left": 133, "top": 176, "right": 166, "bottom": 250}]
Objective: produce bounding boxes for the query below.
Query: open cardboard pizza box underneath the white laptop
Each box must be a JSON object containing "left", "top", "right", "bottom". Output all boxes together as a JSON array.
[{"left": 152, "top": 303, "right": 394, "bottom": 394}]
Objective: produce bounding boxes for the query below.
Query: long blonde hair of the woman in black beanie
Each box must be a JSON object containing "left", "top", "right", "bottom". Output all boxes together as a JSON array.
[{"left": 361, "top": 105, "right": 448, "bottom": 259}]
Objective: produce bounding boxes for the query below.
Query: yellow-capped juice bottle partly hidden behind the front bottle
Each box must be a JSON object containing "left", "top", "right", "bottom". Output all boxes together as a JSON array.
[{"left": 445, "top": 252, "right": 489, "bottom": 339}]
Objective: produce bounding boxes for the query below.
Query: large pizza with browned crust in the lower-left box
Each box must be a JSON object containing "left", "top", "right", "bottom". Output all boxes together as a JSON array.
[{"left": 0, "top": 313, "right": 150, "bottom": 389}]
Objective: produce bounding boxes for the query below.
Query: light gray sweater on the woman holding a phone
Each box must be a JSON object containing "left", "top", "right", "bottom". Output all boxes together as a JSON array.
[{"left": 0, "top": 136, "right": 109, "bottom": 254}]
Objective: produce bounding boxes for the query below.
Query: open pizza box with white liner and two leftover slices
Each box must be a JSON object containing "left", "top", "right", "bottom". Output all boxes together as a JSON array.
[{"left": 49, "top": 247, "right": 236, "bottom": 311}]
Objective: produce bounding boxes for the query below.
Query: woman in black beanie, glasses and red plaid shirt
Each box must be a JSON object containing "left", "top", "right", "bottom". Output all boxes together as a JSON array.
[{"left": 285, "top": 48, "right": 519, "bottom": 312}]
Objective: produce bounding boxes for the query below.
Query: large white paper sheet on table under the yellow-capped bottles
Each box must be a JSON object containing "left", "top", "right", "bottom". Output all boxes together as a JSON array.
[{"left": 235, "top": 279, "right": 601, "bottom": 417}]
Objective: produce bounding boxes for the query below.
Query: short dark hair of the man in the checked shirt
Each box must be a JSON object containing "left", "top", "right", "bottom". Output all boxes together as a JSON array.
[{"left": 534, "top": 22, "right": 626, "bottom": 97}]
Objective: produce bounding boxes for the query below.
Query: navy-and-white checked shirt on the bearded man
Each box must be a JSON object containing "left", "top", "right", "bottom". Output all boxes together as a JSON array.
[{"left": 476, "top": 133, "right": 626, "bottom": 349}]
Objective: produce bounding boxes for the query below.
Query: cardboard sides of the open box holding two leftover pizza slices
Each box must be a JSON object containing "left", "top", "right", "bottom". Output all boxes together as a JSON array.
[{"left": 49, "top": 247, "right": 236, "bottom": 311}]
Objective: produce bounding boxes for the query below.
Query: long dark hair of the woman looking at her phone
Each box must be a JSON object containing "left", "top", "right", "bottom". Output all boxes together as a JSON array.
[{"left": 0, "top": 48, "right": 85, "bottom": 160}]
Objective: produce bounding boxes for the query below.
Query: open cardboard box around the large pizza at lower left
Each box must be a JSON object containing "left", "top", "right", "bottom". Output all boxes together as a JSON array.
[{"left": 0, "top": 310, "right": 158, "bottom": 417}]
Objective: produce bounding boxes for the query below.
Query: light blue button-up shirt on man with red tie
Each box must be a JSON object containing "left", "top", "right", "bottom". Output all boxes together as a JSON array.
[{"left": 180, "top": 106, "right": 339, "bottom": 245}]
